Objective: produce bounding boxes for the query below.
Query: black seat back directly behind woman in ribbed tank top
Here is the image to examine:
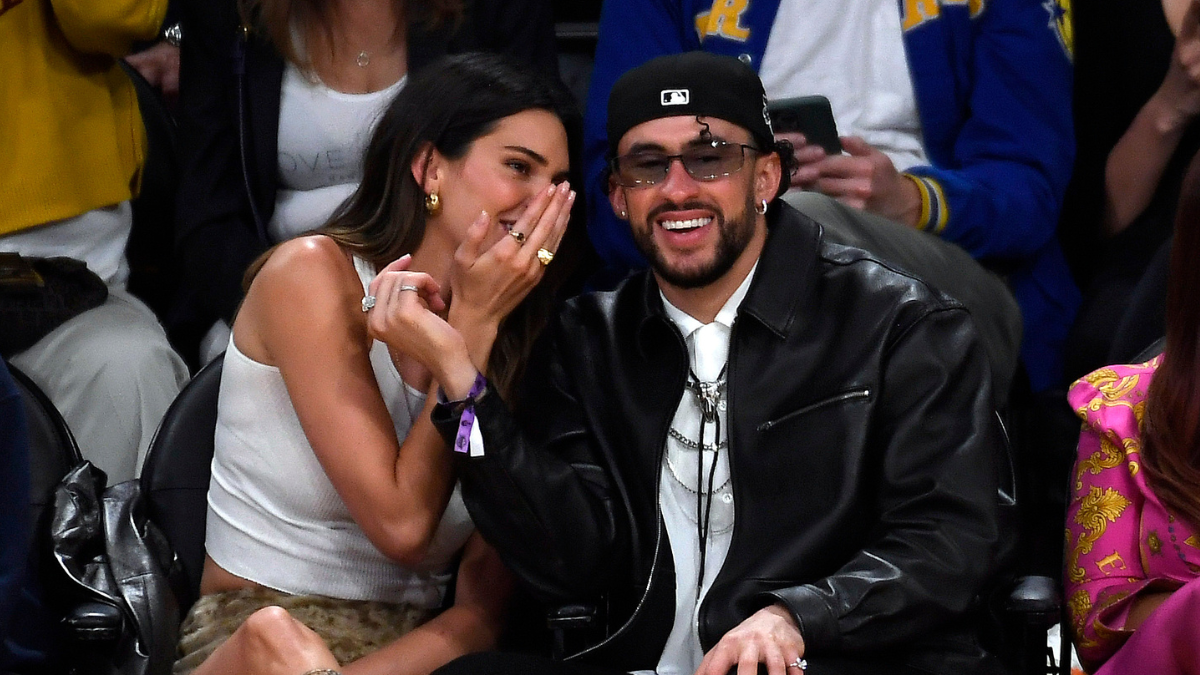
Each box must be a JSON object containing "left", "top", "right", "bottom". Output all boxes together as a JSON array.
[{"left": 142, "top": 356, "right": 224, "bottom": 614}]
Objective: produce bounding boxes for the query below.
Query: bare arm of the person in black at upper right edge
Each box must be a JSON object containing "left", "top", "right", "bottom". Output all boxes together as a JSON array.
[{"left": 1104, "top": 1, "right": 1200, "bottom": 235}]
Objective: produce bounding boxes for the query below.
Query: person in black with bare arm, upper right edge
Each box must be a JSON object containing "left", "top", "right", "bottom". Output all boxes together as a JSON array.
[{"left": 1063, "top": 0, "right": 1200, "bottom": 377}]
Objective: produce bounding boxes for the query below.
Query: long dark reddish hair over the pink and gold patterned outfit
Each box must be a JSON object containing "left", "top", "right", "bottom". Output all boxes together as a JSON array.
[{"left": 1141, "top": 147, "right": 1200, "bottom": 528}]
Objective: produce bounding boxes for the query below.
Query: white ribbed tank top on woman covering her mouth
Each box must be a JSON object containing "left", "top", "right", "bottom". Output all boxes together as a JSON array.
[{"left": 205, "top": 257, "right": 474, "bottom": 600}]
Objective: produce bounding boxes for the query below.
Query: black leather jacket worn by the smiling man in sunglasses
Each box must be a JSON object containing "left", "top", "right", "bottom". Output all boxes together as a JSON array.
[{"left": 434, "top": 203, "right": 1012, "bottom": 674}]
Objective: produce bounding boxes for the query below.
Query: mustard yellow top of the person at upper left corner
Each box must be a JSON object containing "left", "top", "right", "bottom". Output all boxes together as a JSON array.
[{"left": 0, "top": 0, "right": 167, "bottom": 235}]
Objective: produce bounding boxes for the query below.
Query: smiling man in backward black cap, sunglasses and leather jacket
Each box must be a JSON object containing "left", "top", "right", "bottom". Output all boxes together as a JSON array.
[{"left": 431, "top": 52, "right": 1009, "bottom": 675}]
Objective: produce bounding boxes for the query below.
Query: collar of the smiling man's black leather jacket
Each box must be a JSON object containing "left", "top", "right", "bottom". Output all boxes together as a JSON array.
[{"left": 638, "top": 199, "right": 822, "bottom": 340}]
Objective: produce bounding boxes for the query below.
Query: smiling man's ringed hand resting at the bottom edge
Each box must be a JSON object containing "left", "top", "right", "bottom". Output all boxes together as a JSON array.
[{"left": 696, "top": 604, "right": 804, "bottom": 675}]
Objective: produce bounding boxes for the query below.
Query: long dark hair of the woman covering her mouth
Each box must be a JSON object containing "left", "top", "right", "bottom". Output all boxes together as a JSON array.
[{"left": 246, "top": 53, "right": 580, "bottom": 394}]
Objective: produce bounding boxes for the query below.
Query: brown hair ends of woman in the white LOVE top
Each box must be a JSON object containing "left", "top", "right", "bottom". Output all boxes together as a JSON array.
[{"left": 238, "top": 0, "right": 463, "bottom": 71}]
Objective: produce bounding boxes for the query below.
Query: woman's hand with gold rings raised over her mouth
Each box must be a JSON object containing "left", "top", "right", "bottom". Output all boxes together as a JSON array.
[{"left": 450, "top": 181, "right": 575, "bottom": 329}]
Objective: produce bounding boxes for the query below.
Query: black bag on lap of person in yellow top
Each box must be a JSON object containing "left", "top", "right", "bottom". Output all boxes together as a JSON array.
[{"left": 0, "top": 253, "right": 108, "bottom": 358}]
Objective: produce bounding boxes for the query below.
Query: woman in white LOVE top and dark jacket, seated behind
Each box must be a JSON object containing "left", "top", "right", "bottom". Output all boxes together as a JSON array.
[{"left": 170, "top": 0, "right": 557, "bottom": 360}]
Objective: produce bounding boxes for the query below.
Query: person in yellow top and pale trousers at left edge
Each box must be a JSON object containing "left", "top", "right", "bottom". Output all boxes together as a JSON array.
[{"left": 0, "top": 0, "right": 188, "bottom": 483}]
